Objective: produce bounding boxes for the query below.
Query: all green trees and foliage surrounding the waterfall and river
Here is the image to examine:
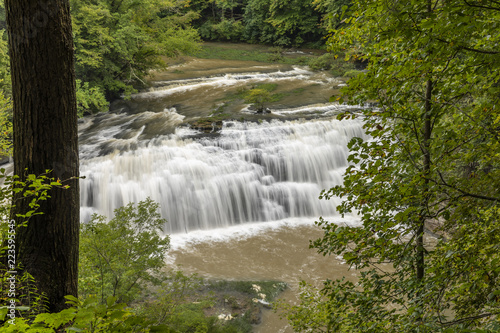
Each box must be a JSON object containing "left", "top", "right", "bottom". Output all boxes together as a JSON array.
[{"left": 0, "top": 0, "right": 500, "bottom": 333}]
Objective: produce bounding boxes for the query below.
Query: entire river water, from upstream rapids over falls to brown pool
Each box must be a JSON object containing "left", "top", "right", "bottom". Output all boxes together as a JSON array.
[{"left": 79, "top": 53, "right": 363, "bottom": 332}]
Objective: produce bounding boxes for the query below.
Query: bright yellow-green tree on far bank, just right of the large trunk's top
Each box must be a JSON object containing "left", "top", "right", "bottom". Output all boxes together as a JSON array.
[{"left": 71, "top": 0, "right": 198, "bottom": 99}]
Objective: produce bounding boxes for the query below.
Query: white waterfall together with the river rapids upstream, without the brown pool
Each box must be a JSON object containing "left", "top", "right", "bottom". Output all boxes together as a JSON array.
[{"left": 80, "top": 60, "right": 363, "bottom": 233}]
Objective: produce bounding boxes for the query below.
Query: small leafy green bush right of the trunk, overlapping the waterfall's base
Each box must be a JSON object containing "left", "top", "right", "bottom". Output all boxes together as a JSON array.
[{"left": 79, "top": 198, "right": 170, "bottom": 302}]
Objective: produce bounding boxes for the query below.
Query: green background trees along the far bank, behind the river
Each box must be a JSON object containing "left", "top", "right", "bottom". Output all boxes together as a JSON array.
[{"left": 0, "top": 0, "right": 344, "bottom": 116}]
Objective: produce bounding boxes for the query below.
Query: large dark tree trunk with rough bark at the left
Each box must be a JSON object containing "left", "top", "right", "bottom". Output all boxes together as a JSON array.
[{"left": 5, "top": 0, "right": 80, "bottom": 311}]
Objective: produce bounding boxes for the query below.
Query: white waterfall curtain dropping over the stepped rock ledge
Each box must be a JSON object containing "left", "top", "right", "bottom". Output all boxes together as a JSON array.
[{"left": 80, "top": 119, "right": 364, "bottom": 233}]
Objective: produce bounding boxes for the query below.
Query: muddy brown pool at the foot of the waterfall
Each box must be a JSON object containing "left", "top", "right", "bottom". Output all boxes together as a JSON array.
[{"left": 165, "top": 223, "right": 356, "bottom": 333}]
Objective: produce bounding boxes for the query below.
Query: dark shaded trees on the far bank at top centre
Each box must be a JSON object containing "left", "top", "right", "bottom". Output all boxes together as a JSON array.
[{"left": 191, "top": 0, "right": 326, "bottom": 46}]
